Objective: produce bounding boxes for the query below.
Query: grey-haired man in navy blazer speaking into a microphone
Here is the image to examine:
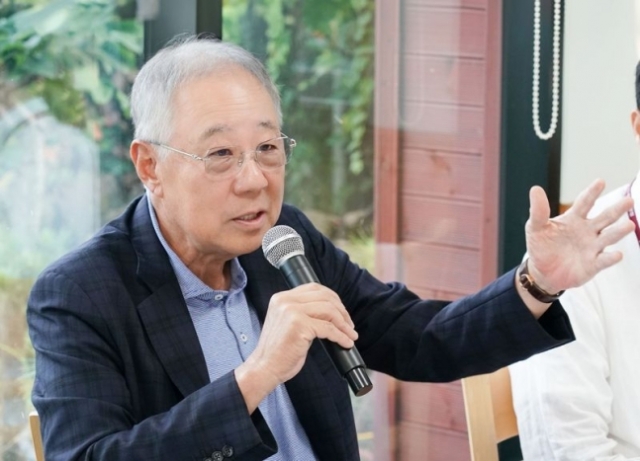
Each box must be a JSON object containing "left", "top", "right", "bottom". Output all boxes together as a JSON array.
[{"left": 28, "top": 38, "right": 631, "bottom": 461}]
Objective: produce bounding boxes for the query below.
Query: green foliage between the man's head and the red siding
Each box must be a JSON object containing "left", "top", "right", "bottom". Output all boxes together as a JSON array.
[{"left": 223, "top": 0, "right": 374, "bottom": 235}]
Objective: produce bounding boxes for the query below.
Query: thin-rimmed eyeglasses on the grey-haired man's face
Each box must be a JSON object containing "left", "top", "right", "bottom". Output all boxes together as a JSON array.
[{"left": 147, "top": 134, "right": 297, "bottom": 181}]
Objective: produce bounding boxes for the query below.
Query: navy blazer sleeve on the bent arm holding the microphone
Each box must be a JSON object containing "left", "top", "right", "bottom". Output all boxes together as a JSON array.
[{"left": 27, "top": 270, "right": 276, "bottom": 461}]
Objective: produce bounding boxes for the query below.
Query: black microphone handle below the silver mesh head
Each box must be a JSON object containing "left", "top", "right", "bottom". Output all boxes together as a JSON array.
[{"left": 280, "top": 255, "right": 373, "bottom": 397}]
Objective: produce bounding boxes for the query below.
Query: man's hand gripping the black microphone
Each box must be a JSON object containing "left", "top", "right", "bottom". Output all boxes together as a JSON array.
[{"left": 235, "top": 283, "right": 358, "bottom": 413}]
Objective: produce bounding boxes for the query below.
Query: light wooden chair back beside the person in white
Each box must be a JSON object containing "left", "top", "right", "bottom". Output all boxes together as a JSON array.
[{"left": 462, "top": 368, "right": 522, "bottom": 461}]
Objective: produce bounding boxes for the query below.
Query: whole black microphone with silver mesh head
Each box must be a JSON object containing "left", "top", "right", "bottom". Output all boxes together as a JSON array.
[{"left": 262, "top": 226, "right": 373, "bottom": 397}]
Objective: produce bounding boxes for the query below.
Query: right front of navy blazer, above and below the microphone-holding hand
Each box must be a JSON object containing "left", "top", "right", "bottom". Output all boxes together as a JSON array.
[{"left": 240, "top": 250, "right": 353, "bottom": 460}]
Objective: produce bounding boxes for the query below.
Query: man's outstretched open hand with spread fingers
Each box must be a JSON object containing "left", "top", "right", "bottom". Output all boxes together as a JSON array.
[{"left": 525, "top": 180, "right": 634, "bottom": 293}]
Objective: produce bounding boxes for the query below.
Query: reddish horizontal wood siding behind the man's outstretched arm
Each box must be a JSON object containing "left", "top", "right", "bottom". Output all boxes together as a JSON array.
[{"left": 375, "top": 0, "right": 502, "bottom": 461}]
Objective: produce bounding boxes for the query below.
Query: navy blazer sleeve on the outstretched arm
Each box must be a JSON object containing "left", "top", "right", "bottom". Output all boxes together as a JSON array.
[{"left": 288, "top": 205, "right": 574, "bottom": 382}]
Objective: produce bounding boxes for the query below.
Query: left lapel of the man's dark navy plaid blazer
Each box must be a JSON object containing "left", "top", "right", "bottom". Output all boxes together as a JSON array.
[{"left": 131, "top": 196, "right": 209, "bottom": 396}]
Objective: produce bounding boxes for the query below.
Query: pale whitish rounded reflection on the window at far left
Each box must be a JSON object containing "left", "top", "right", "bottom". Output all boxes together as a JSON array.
[{"left": 0, "top": 97, "right": 98, "bottom": 279}]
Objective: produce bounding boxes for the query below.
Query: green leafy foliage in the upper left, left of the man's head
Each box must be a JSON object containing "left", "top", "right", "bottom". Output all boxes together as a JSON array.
[{"left": 0, "top": 0, "right": 143, "bottom": 219}]
